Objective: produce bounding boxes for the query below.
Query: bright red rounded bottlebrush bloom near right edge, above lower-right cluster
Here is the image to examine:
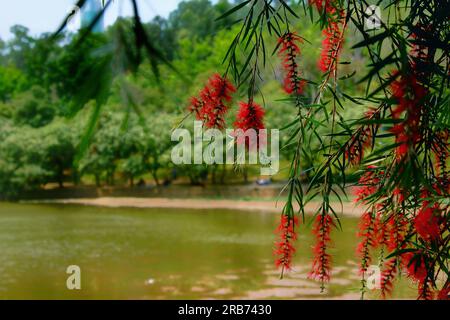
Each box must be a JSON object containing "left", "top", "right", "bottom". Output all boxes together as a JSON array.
[{"left": 414, "top": 202, "right": 440, "bottom": 240}]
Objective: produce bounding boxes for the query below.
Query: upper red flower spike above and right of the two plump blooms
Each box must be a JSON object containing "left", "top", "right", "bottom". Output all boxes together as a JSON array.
[{"left": 278, "top": 32, "right": 305, "bottom": 94}]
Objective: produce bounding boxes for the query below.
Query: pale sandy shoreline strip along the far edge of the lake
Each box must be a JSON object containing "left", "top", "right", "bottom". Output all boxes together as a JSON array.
[{"left": 21, "top": 197, "right": 364, "bottom": 217}]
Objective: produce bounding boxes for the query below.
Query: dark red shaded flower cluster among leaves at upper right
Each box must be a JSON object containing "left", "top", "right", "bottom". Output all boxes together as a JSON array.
[{"left": 390, "top": 75, "right": 427, "bottom": 160}]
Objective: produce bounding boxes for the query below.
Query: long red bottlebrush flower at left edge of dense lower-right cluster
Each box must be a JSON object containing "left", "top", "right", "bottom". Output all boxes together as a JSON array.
[{"left": 356, "top": 212, "right": 377, "bottom": 274}]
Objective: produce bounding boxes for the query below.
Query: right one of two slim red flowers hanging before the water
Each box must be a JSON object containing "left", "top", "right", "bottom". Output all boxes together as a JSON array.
[{"left": 309, "top": 213, "right": 334, "bottom": 290}]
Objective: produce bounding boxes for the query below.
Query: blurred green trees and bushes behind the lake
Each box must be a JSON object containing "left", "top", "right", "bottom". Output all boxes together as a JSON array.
[{"left": 0, "top": 0, "right": 367, "bottom": 197}]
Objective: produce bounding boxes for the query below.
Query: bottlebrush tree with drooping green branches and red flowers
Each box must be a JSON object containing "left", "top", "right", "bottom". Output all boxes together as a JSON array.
[{"left": 185, "top": 0, "right": 450, "bottom": 299}]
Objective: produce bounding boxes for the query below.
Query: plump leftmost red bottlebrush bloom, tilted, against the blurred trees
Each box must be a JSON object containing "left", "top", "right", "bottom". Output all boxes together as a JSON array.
[{"left": 188, "top": 73, "right": 236, "bottom": 129}]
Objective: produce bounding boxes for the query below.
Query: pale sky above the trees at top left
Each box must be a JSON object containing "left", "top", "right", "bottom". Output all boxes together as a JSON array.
[{"left": 0, "top": 0, "right": 182, "bottom": 40}]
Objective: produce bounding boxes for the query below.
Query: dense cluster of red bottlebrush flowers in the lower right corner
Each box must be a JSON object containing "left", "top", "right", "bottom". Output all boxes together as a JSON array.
[{"left": 356, "top": 166, "right": 449, "bottom": 299}]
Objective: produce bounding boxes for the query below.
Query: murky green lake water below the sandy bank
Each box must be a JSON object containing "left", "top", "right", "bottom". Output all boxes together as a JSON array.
[{"left": 0, "top": 203, "right": 415, "bottom": 299}]
